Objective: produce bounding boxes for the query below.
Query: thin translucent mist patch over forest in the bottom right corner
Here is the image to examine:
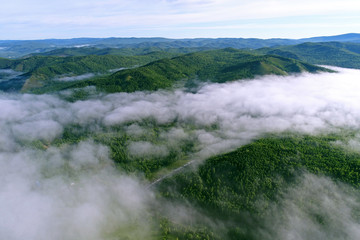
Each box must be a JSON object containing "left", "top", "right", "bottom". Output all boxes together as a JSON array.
[{"left": 258, "top": 173, "right": 360, "bottom": 240}]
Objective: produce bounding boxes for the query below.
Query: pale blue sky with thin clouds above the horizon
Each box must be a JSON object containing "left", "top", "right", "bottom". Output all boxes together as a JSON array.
[{"left": 0, "top": 0, "right": 360, "bottom": 39}]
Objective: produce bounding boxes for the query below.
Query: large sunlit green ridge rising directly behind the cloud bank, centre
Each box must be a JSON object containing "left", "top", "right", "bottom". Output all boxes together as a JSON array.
[{"left": 57, "top": 48, "right": 329, "bottom": 92}]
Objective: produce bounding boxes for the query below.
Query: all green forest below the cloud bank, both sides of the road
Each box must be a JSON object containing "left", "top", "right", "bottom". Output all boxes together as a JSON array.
[{"left": 30, "top": 104, "right": 360, "bottom": 239}]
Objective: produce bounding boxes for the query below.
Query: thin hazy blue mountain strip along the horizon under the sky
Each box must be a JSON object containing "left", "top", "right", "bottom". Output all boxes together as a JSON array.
[{"left": 0, "top": 33, "right": 360, "bottom": 58}]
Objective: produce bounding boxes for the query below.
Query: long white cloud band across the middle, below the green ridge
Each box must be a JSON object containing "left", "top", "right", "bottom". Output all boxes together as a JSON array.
[{"left": 0, "top": 66, "right": 360, "bottom": 156}]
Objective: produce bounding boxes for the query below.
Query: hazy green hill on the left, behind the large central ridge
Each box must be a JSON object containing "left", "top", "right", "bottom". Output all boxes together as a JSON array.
[{"left": 0, "top": 52, "right": 178, "bottom": 91}]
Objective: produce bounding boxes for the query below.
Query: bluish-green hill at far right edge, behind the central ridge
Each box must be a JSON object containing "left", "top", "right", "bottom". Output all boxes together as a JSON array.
[{"left": 257, "top": 42, "right": 360, "bottom": 68}]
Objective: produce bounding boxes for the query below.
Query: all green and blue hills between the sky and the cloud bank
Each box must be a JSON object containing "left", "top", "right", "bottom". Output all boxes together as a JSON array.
[{"left": 0, "top": 34, "right": 360, "bottom": 93}]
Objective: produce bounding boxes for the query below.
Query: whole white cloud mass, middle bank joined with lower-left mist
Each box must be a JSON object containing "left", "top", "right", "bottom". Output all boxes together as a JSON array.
[{"left": 0, "top": 66, "right": 360, "bottom": 240}]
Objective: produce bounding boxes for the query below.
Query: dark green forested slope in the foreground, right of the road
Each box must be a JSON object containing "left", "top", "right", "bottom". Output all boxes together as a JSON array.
[{"left": 159, "top": 136, "right": 360, "bottom": 239}]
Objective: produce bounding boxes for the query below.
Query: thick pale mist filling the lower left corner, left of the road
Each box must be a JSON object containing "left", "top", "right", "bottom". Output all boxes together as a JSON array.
[{"left": 0, "top": 142, "right": 152, "bottom": 240}]
